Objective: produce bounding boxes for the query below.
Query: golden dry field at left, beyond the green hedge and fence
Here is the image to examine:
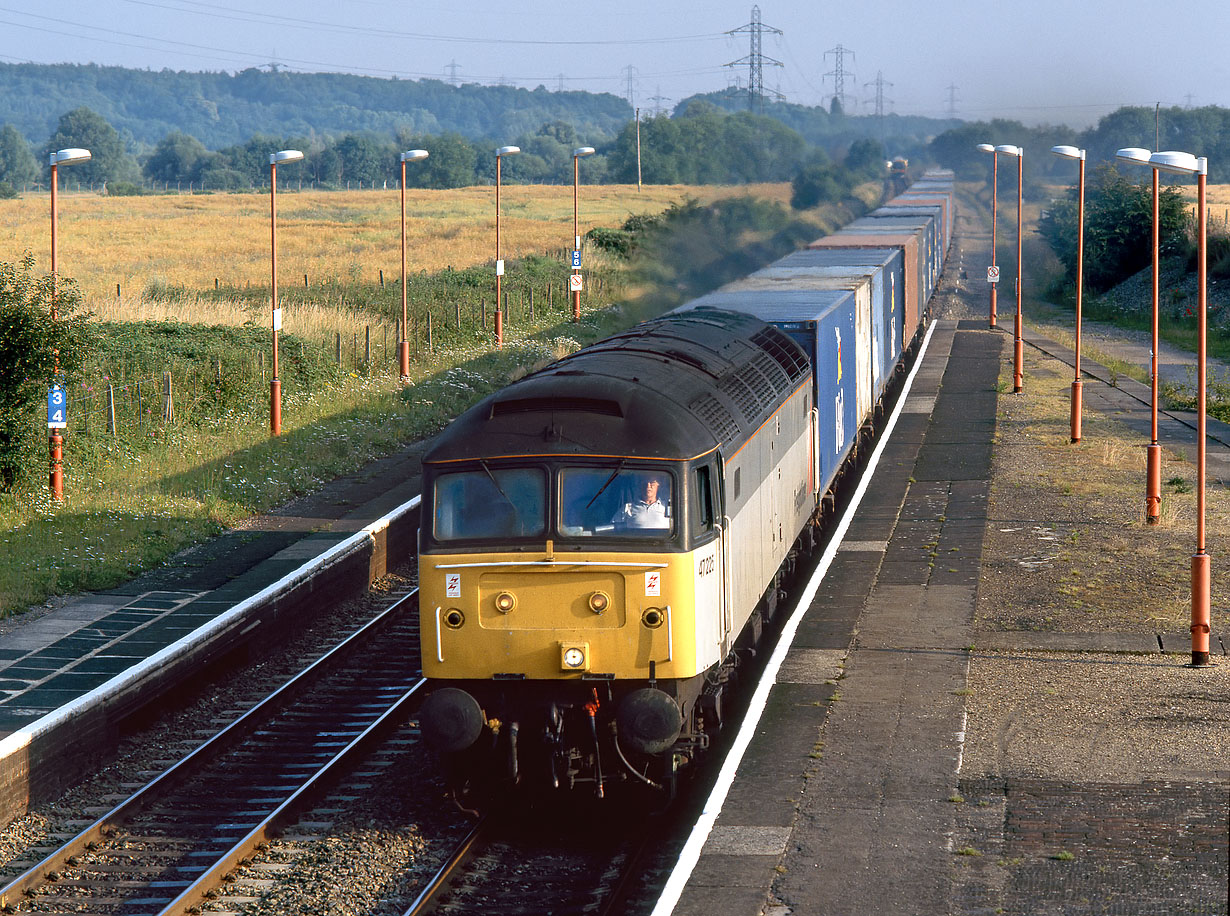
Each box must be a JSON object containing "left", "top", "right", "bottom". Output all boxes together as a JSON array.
[{"left": 0, "top": 182, "right": 790, "bottom": 311}]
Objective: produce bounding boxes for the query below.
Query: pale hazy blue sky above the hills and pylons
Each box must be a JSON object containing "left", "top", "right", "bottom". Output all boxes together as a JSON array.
[{"left": 0, "top": 0, "right": 1230, "bottom": 127}]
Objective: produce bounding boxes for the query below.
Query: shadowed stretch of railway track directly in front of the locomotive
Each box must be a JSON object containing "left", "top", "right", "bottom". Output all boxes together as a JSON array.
[{"left": 405, "top": 805, "right": 662, "bottom": 916}]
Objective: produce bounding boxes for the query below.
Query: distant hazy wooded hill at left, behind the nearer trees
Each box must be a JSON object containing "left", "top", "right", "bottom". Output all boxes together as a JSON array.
[{"left": 0, "top": 63, "right": 632, "bottom": 151}]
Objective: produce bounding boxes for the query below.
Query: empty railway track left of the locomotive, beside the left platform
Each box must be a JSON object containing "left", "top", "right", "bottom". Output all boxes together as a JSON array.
[{"left": 0, "top": 590, "right": 422, "bottom": 915}]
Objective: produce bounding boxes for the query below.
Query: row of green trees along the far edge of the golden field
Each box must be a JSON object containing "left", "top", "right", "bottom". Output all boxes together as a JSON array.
[{"left": 0, "top": 100, "right": 905, "bottom": 194}]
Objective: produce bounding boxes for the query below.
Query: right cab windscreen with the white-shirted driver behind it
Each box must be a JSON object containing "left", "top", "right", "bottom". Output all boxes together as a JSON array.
[{"left": 560, "top": 465, "right": 674, "bottom": 537}]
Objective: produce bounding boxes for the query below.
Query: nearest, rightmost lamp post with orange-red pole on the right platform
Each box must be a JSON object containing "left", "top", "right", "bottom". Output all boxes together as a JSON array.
[{"left": 1149, "top": 150, "right": 1213, "bottom": 668}]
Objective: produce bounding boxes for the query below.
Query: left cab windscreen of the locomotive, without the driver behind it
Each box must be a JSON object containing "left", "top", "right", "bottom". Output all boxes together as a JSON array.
[{"left": 433, "top": 466, "right": 546, "bottom": 541}]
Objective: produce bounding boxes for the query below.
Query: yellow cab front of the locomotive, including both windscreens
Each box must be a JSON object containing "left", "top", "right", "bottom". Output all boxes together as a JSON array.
[{"left": 419, "top": 462, "right": 717, "bottom": 680}]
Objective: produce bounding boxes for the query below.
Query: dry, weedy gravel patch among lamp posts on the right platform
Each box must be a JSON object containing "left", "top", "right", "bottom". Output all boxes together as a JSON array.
[{"left": 980, "top": 339, "right": 1230, "bottom": 633}]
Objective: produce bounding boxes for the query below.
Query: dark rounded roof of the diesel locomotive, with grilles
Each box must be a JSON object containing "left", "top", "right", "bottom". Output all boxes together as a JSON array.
[{"left": 424, "top": 309, "right": 811, "bottom": 462}]
